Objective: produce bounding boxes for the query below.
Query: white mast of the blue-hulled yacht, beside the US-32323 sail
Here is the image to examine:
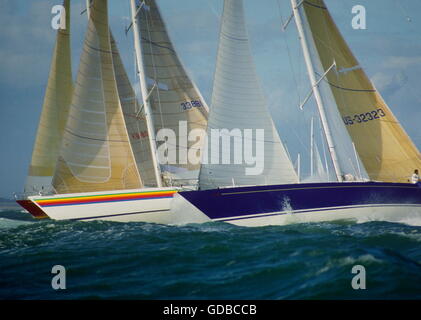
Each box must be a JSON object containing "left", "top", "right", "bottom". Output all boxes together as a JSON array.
[{"left": 291, "top": 0, "right": 343, "bottom": 182}]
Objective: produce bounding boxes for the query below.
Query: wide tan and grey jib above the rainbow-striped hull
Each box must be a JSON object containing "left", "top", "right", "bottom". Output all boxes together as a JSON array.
[{"left": 53, "top": 0, "right": 142, "bottom": 193}]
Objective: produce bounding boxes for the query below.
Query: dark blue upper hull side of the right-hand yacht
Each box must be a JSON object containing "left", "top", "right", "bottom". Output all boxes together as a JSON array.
[{"left": 179, "top": 182, "right": 421, "bottom": 220}]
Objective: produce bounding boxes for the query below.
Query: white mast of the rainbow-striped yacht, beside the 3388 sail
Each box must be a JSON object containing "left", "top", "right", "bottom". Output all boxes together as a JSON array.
[{"left": 130, "top": 0, "right": 162, "bottom": 188}]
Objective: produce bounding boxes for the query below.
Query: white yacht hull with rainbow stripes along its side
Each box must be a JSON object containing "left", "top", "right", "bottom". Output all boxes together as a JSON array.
[{"left": 17, "top": 187, "right": 178, "bottom": 224}]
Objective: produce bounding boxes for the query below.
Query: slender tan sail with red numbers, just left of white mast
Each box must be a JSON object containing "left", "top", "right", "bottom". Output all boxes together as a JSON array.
[{"left": 110, "top": 32, "right": 156, "bottom": 186}]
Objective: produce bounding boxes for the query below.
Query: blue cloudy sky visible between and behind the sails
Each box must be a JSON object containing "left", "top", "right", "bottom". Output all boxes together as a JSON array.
[{"left": 0, "top": 0, "right": 421, "bottom": 198}]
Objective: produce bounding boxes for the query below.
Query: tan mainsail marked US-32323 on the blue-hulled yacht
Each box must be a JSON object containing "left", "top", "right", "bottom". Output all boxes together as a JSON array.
[{"left": 301, "top": 0, "right": 421, "bottom": 182}]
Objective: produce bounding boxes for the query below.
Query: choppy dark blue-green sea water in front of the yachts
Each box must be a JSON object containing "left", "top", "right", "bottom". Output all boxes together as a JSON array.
[{"left": 0, "top": 209, "right": 421, "bottom": 299}]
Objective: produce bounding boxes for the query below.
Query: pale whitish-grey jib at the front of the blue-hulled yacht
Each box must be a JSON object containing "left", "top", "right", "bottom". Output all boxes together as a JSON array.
[{"left": 199, "top": 0, "right": 298, "bottom": 189}]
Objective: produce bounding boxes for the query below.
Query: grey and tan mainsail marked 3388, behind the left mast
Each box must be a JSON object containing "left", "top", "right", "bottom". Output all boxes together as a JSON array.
[{"left": 136, "top": 0, "right": 208, "bottom": 183}]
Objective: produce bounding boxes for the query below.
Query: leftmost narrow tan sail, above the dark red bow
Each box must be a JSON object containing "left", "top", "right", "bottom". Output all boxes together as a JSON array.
[{"left": 25, "top": 0, "right": 73, "bottom": 193}]
